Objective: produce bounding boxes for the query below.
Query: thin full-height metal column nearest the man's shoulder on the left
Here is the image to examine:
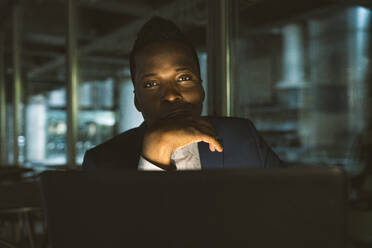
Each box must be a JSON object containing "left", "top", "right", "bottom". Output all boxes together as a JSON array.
[{"left": 66, "top": 0, "right": 78, "bottom": 169}]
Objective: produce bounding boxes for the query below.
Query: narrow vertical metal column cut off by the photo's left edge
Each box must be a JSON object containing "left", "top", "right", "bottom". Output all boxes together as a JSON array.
[{"left": 0, "top": 33, "right": 8, "bottom": 167}]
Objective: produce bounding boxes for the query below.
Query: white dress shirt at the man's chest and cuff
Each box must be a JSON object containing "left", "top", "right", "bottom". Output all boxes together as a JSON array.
[{"left": 138, "top": 143, "right": 201, "bottom": 171}]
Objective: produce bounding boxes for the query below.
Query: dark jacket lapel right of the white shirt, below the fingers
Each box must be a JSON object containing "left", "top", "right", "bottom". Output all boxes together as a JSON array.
[{"left": 198, "top": 140, "right": 224, "bottom": 169}]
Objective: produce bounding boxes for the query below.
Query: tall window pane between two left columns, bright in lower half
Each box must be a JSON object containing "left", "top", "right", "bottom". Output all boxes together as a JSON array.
[{"left": 20, "top": 1, "right": 67, "bottom": 166}]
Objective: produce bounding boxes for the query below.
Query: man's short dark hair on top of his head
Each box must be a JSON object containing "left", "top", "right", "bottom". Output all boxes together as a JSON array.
[{"left": 129, "top": 16, "right": 200, "bottom": 84}]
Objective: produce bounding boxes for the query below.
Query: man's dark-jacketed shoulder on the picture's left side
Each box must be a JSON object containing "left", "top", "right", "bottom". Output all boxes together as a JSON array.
[{"left": 83, "top": 127, "right": 142, "bottom": 169}]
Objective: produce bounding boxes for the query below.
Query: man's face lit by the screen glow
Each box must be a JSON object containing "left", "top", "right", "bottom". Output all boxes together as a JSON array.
[{"left": 134, "top": 42, "right": 204, "bottom": 126}]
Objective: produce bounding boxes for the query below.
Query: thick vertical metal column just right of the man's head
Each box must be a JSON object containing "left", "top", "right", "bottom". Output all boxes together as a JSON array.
[{"left": 207, "top": 0, "right": 233, "bottom": 116}]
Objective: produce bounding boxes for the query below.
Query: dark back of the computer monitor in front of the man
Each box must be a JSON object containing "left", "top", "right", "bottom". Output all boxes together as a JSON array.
[{"left": 41, "top": 168, "right": 347, "bottom": 248}]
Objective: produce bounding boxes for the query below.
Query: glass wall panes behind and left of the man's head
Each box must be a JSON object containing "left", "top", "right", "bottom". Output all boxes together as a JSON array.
[{"left": 9, "top": 0, "right": 208, "bottom": 168}]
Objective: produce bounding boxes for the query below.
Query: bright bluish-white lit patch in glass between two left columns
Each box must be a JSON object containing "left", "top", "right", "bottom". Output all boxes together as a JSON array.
[{"left": 26, "top": 89, "right": 67, "bottom": 165}]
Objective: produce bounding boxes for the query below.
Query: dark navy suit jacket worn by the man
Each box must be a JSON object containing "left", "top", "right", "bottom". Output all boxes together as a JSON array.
[{"left": 83, "top": 117, "right": 281, "bottom": 170}]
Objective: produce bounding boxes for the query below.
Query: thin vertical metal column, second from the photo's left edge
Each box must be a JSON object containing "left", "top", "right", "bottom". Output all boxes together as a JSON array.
[{"left": 13, "top": 2, "right": 22, "bottom": 166}]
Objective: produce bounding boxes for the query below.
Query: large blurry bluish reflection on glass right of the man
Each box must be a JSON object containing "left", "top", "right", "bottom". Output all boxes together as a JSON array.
[{"left": 234, "top": 7, "right": 371, "bottom": 174}]
